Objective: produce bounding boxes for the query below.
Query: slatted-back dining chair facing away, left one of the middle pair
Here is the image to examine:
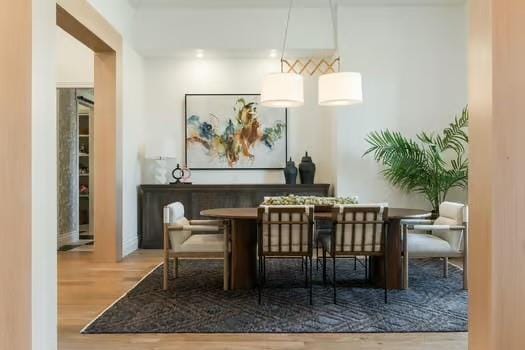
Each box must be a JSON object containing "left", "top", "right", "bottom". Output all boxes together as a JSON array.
[{"left": 257, "top": 205, "right": 314, "bottom": 305}]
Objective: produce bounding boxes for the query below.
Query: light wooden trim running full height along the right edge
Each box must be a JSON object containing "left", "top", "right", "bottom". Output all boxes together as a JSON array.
[{"left": 469, "top": 0, "right": 525, "bottom": 350}]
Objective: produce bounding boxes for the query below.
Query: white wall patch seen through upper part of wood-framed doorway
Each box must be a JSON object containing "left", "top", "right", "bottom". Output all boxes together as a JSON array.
[{"left": 55, "top": 26, "right": 95, "bottom": 87}]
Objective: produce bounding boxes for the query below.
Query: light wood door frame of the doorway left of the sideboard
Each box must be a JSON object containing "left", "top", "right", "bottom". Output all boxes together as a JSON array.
[{"left": 56, "top": 1, "right": 122, "bottom": 261}]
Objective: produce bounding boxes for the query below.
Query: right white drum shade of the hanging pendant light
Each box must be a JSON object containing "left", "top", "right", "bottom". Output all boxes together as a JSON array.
[{"left": 319, "top": 72, "right": 363, "bottom": 106}]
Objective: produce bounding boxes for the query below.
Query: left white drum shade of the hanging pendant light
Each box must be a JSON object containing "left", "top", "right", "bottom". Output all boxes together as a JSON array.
[{"left": 261, "top": 73, "right": 304, "bottom": 108}]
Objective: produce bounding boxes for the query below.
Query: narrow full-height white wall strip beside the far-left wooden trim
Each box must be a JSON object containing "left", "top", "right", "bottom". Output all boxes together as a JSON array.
[{"left": 32, "top": 0, "right": 57, "bottom": 350}]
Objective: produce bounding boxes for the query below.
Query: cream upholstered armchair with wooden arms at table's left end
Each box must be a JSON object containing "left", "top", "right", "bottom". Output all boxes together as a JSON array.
[{"left": 163, "top": 202, "right": 231, "bottom": 290}]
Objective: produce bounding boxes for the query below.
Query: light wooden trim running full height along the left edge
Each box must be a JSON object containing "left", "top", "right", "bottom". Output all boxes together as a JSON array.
[{"left": 0, "top": 0, "right": 32, "bottom": 350}]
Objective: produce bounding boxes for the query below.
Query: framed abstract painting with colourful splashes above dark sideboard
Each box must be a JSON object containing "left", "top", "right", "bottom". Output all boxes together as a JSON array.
[{"left": 185, "top": 94, "right": 288, "bottom": 170}]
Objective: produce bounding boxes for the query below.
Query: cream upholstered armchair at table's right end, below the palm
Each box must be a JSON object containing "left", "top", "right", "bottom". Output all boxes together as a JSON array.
[{"left": 401, "top": 202, "right": 468, "bottom": 289}]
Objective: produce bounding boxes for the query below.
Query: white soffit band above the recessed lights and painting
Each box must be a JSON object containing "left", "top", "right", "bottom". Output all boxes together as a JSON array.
[{"left": 134, "top": 7, "right": 333, "bottom": 55}]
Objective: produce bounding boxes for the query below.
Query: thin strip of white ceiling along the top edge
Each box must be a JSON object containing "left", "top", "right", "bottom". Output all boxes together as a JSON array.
[{"left": 128, "top": 0, "right": 466, "bottom": 8}]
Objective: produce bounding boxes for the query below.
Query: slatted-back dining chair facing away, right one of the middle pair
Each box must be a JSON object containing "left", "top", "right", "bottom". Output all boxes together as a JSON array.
[{"left": 320, "top": 203, "right": 388, "bottom": 304}]
